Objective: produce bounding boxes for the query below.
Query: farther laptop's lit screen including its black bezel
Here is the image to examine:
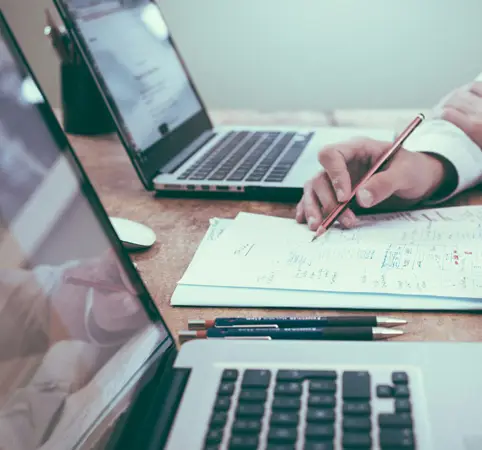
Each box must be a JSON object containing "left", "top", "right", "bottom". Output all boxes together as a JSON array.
[{"left": 56, "top": 0, "right": 208, "bottom": 186}]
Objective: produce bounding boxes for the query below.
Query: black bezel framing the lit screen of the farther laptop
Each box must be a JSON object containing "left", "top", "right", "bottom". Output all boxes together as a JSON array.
[{"left": 53, "top": 0, "right": 213, "bottom": 190}]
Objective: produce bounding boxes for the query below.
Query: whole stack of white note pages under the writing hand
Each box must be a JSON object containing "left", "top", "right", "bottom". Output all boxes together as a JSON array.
[{"left": 171, "top": 206, "right": 482, "bottom": 310}]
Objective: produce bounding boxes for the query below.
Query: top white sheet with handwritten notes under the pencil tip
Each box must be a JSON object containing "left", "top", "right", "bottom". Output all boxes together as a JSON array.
[{"left": 180, "top": 207, "right": 482, "bottom": 298}]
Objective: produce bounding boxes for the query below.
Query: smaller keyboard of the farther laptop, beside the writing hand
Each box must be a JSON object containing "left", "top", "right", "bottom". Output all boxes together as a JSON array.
[{"left": 178, "top": 131, "right": 313, "bottom": 182}]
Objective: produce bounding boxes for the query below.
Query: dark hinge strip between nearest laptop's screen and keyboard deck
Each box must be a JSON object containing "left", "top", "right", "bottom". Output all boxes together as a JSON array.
[{"left": 108, "top": 350, "right": 191, "bottom": 450}]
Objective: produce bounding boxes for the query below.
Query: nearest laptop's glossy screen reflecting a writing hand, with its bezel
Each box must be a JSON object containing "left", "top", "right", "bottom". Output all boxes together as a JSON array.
[{"left": 0, "top": 13, "right": 173, "bottom": 450}]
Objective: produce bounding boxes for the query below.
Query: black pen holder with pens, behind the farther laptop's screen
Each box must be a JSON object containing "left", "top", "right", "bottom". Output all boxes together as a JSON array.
[{"left": 44, "top": 10, "right": 115, "bottom": 136}]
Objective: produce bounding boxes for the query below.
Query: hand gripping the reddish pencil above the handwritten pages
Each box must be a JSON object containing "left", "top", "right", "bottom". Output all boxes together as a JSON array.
[{"left": 296, "top": 139, "right": 446, "bottom": 231}]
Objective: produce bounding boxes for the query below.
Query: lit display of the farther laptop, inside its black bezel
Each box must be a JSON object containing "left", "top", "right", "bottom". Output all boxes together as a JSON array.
[{"left": 64, "top": 0, "right": 201, "bottom": 152}]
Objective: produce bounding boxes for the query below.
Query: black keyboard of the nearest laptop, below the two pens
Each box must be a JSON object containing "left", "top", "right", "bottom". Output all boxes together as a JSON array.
[{"left": 204, "top": 369, "right": 417, "bottom": 450}]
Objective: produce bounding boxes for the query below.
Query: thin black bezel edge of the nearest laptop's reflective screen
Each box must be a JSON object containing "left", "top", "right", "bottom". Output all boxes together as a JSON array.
[{"left": 0, "top": 1, "right": 175, "bottom": 370}]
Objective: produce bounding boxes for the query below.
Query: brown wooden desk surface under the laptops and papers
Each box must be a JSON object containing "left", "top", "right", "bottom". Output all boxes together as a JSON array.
[{"left": 67, "top": 110, "right": 482, "bottom": 341}]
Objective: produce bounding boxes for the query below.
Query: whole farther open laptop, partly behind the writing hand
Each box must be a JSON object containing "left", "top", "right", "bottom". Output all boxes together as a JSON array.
[{"left": 54, "top": 0, "right": 393, "bottom": 200}]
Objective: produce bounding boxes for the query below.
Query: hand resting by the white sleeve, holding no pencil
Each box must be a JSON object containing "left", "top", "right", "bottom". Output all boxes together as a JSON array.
[{"left": 434, "top": 81, "right": 482, "bottom": 149}]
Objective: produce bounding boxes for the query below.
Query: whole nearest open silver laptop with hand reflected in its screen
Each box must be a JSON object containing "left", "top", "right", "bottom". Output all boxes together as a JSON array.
[{"left": 0, "top": 12, "right": 482, "bottom": 450}]
